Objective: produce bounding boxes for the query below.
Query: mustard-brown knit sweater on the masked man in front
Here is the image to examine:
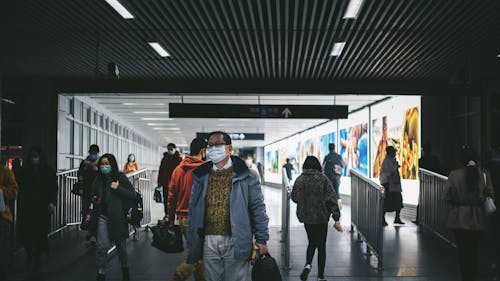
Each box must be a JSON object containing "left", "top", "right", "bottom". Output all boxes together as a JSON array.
[{"left": 205, "top": 167, "right": 233, "bottom": 235}]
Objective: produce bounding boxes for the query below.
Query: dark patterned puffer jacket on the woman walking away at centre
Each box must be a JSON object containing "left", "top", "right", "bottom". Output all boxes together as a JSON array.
[{"left": 292, "top": 169, "right": 340, "bottom": 224}]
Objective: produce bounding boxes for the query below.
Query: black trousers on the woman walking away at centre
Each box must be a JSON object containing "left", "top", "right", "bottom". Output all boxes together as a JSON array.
[{"left": 304, "top": 223, "right": 328, "bottom": 277}]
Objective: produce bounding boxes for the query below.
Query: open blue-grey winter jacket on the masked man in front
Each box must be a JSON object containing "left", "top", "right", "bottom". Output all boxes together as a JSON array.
[{"left": 187, "top": 157, "right": 269, "bottom": 264}]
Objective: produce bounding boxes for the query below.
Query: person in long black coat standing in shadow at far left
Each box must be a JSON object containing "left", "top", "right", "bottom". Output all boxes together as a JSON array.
[{"left": 17, "top": 147, "right": 57, "bottom": 270}]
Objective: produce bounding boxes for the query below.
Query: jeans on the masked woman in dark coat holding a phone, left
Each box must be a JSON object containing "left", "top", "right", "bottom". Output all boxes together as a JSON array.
[{"left": 96, "top": 215, "right": 128, "bottom": 274}]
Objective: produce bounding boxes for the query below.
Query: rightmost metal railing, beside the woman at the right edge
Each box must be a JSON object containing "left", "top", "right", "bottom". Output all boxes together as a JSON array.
[{"left": 418, "top": 168, "right": 454, "bottom": 245}]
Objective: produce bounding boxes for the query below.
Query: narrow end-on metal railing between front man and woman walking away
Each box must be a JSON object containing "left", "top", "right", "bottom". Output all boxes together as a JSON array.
[{"left": 281, "top": 169, "right": 292, "bottom": 269}]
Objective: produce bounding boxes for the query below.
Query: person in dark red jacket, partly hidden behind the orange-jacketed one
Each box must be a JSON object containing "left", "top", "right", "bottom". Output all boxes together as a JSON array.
[{"left": 158, "top": 143, "right": 182, "bottom": 217}]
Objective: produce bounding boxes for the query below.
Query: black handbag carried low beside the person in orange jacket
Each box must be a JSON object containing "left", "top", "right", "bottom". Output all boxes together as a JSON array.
[{"left": 150, "top": 220, "right": 184, "bottom": 253}]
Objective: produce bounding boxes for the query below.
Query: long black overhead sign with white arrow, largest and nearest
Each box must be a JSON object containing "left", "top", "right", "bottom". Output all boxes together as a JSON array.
[{"left": 169, "top": 103, "right": 349, "bottom": 119}]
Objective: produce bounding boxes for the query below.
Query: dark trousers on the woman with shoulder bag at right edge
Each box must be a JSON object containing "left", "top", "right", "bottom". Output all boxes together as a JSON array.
[{"left": 454, "top": 229, "right": 481, "bottom": 281}]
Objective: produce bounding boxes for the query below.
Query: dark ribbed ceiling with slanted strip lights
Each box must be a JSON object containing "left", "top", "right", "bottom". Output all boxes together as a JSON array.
[{"left": 0, "top": 0, "right": 500, "bottom": 80}]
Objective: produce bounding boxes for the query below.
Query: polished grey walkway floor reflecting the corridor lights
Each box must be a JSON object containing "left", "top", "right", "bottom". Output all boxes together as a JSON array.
[{"left": 4, "top": 185, "right": 500, "bottom": 281}]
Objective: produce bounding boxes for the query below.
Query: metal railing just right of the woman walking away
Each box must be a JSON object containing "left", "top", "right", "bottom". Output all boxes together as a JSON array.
[{"left": 350, "top": 170, "right": 384, "bottom": 270}]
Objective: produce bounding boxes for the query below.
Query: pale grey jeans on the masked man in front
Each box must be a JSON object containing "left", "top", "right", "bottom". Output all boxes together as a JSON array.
[{"left": 203, "top": 235, "right": 250, "bottom": 281}]
